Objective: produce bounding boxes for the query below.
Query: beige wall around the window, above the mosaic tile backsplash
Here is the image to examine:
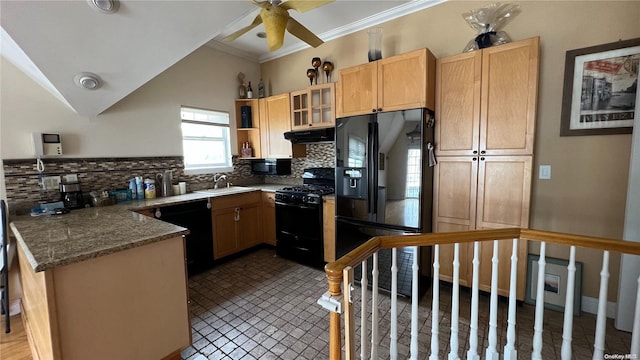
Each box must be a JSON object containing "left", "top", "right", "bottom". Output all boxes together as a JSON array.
[{"left": 0, "top": 47, "right": 260, "bottom": 159}]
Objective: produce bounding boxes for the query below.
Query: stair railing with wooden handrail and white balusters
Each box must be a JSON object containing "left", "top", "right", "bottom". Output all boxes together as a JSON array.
[{"left": 318, "top": 228, "right": 640, "bottom": 360}]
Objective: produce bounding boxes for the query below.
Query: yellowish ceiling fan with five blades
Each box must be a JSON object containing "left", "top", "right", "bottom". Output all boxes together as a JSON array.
[{"left": 225, "top": 0, "right": 335, "bottom": 51}]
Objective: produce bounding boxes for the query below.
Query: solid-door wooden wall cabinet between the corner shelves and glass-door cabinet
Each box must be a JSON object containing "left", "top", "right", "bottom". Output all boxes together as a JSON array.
[{"left": 258, "top": 93, "right": 307, "bottom": 158}]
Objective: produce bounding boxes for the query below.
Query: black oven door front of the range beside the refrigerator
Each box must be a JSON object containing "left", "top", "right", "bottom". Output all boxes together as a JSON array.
[{"left": 276, "top": 201, "right": 324, "bottom": 266}]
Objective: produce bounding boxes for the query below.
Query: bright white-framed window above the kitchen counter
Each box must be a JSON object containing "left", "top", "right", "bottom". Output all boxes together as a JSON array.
[{"left": 180, "top": 107, "right": 233, "bottom": 174}]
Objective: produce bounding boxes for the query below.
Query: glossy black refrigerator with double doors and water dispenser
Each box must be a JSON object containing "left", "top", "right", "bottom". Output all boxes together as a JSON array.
[{"left": 335, "top": 108, "right": 435, "bottom": 297}]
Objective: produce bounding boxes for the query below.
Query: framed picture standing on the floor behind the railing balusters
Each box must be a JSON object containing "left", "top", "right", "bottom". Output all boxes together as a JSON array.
[{"left": 524, "top": 255, "right": 582, "bottom": 316}]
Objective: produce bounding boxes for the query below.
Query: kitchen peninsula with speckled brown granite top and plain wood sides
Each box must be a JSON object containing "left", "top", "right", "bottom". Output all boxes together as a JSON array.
[{"left": 11, "top": 200, "right": 195, "bottom": 359}]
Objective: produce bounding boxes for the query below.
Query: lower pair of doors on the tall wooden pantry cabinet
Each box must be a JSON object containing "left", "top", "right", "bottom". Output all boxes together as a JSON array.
[{"left": 434, "top": 156, "right": 532, "bottom": 300}]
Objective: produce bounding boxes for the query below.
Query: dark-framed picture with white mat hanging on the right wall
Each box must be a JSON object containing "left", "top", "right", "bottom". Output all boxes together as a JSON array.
[{"left": 560, "top": 38, "right": 640, "bottom": 136}]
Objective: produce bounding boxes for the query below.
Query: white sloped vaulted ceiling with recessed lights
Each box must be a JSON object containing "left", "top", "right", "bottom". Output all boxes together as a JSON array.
[{"left": 0, "top": 0, "right": 445, "bottom": 116}]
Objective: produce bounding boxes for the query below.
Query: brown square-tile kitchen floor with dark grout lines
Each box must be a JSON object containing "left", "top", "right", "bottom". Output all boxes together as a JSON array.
[{"left": 182, "top": 249, "right": 631, "bottom": 360}]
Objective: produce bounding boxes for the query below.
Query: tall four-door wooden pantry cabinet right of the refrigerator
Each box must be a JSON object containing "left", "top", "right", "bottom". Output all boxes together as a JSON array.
[{"left": 433, "top": 38, "right": 539, "bottom": 300}]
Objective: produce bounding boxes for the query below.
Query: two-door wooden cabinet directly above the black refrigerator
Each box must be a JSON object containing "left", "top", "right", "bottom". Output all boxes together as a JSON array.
[{"left": 336, "top": 49, "right": 435, "bottom": 117}]
